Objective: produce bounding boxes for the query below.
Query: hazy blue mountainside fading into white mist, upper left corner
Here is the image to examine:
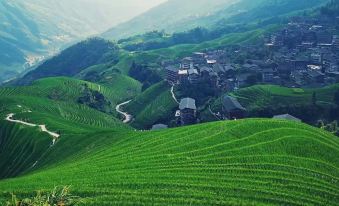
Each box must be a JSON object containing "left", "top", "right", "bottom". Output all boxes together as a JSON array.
[{"left": 0, "top": 0, "right": 162, "bottom": 82}]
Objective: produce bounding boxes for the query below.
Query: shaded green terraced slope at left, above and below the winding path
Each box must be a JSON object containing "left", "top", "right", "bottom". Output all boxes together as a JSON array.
[{"left": 0, "top": 77, "right": 137, "bottom": 178}]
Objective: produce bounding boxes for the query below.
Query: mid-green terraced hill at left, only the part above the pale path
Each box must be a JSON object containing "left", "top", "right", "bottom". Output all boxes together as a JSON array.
[{"left": 0, "top": 77, "right": 138, "bottom": 133}]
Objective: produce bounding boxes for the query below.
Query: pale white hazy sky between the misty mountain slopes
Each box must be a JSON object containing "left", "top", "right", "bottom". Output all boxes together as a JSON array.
[{"left": 20, "top": 0, "right": 167, "bottom": 32}]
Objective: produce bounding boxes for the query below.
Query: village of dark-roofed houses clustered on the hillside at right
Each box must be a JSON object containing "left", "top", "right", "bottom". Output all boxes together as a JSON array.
[{"left": 157, "top": 13, "right": 339, "bottom": 129}]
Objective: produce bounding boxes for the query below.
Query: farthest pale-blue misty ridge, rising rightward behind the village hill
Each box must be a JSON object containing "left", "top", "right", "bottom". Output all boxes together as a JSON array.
[{"left": 103, "top": 0, "right": 327, "bottom": 39}]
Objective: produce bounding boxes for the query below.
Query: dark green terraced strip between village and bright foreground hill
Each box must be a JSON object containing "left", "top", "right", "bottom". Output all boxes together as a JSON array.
[{"left": 204, "top": 84, "right": 339, "bottom": 125}]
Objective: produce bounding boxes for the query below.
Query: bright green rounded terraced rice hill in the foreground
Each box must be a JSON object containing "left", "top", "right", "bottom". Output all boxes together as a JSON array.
[{"left": 0, "top": 119, "right": 339, "bottom": 205}]
